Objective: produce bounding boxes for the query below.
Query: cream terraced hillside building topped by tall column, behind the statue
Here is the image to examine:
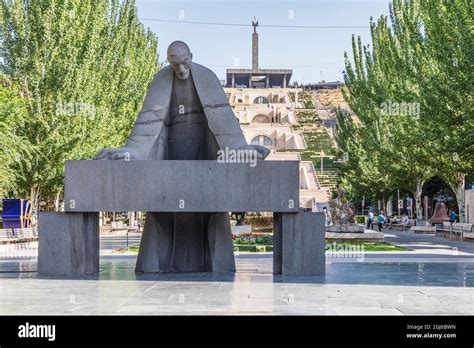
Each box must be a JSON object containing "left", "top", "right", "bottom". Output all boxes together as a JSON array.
[{"left": 224, "top": 21, "right": 348, "bottom": 211}]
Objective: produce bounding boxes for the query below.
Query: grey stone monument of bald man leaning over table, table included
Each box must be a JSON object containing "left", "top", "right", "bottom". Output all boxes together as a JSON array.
[{"left": 38, "top": 41, "right": 325, "bottom": 276}]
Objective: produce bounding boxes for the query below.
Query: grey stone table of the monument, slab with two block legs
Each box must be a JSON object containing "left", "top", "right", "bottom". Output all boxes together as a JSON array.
[{"left": 38, "top": 160, "right": 325, "bottom": 276}]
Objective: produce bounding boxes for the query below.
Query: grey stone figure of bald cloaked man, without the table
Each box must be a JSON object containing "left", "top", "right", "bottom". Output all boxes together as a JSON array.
[{"left": 96, "top": 41, "right": 269, "bottom": 272}]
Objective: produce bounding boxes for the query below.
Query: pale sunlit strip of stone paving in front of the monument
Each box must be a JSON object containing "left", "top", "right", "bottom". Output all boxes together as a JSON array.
[{"left": 0, "top": 280, "right": 474, "bottom": 315}]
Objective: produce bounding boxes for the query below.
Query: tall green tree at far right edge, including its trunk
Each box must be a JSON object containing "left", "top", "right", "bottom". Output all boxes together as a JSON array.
[{"left": 417, "top": 0, "right": 474, "bottom": 222}]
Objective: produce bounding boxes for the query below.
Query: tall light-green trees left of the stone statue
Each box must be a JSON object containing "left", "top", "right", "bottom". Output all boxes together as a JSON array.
[{"left": 1, "top": 0, "right": 158, "bottom": 213}]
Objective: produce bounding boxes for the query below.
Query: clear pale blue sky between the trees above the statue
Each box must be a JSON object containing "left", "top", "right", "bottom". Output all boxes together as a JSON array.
[{"left": 137, "top": 0, "right": 389, "bottom": 83}]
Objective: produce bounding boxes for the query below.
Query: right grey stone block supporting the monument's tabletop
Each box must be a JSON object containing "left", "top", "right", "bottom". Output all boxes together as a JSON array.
[{"left": 273, "top": 211, "right": 326, "bottom": 276}]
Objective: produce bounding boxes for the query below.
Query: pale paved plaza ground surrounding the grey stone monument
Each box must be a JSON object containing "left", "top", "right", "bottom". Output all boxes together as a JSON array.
[{"left": 0, "top": 231, "right": 474, "bottom": 315}]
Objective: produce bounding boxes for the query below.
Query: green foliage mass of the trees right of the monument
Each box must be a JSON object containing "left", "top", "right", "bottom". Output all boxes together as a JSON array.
[{"left": 337, "top": 0, "right": 474, "bottom": 218}]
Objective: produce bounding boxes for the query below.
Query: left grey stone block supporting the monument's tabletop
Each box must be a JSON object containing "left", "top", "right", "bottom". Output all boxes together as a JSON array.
[{"left": 38, "top": 213, "right": 99, "bottom": 276}]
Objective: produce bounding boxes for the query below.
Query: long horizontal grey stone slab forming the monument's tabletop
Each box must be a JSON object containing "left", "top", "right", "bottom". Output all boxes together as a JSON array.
[{"left": 64, "top": 160, "right": 299, "bottom": 213}]
